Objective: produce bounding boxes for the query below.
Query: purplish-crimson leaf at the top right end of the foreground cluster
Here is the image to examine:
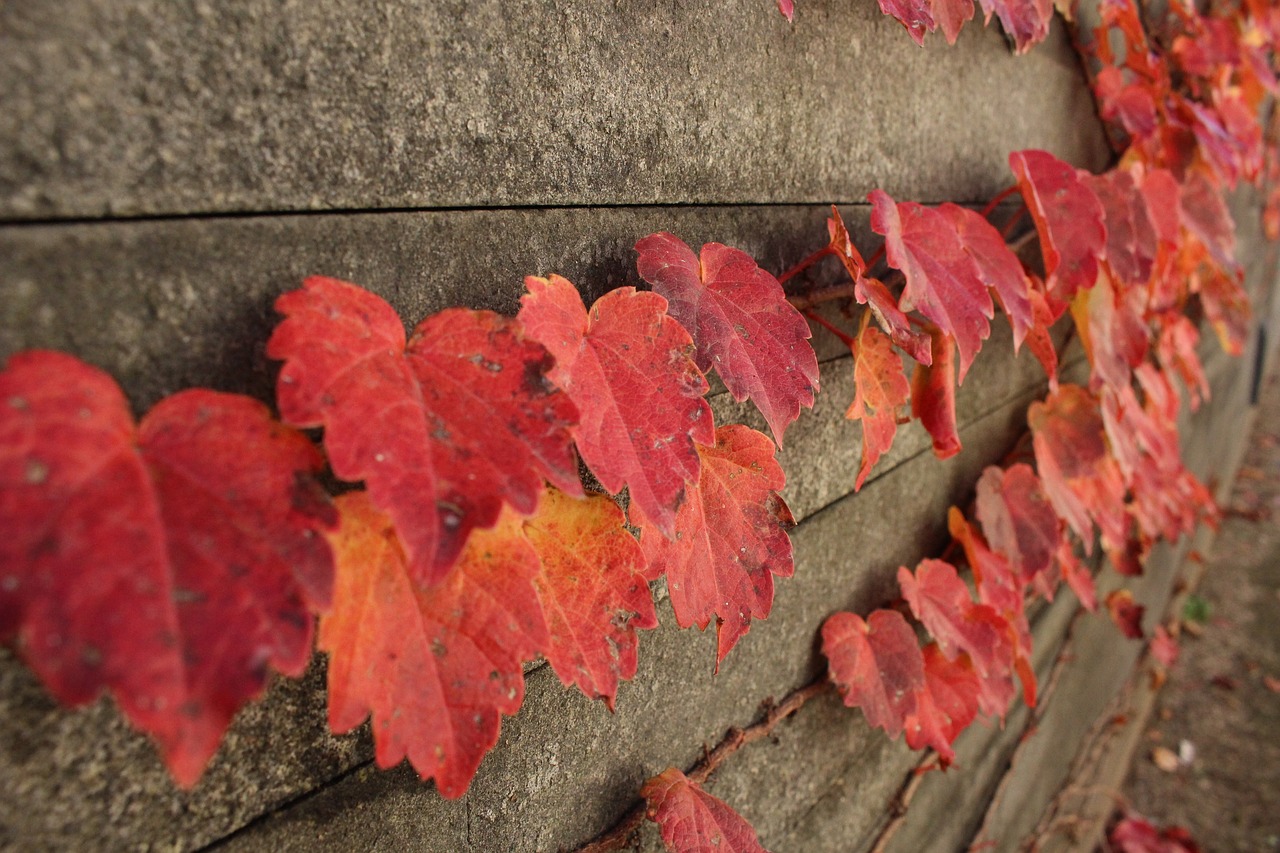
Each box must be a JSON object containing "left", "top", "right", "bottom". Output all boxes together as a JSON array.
[{"left": 636, "top": 232, "right": 818, "bottom": 447}]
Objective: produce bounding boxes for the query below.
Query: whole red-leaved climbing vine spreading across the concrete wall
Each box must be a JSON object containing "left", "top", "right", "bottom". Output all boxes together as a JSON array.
[{"left": 0, "top": 0, "right": 1280, "bottom": 850}]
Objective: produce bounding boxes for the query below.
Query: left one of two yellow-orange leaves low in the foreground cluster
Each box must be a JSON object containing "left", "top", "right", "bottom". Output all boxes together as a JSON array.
[{"left": 319, "top": 492, "right": 548, "bottom": 799}]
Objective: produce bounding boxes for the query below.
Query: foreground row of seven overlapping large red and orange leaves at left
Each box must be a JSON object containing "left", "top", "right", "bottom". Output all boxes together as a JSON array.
[{"left": 0, "top": 234, "right": 818, "bottom": 797}]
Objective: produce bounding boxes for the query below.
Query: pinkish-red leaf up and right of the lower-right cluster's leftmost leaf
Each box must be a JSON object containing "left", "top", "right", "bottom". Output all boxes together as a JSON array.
[{"left": 897, "top": 560, "right": 1015, "bottom": 717}]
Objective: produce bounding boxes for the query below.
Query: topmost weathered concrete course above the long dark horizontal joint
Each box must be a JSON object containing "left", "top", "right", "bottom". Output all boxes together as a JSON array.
[{"left": 0, "top": 0, "right": 1107, "bottom": 219}]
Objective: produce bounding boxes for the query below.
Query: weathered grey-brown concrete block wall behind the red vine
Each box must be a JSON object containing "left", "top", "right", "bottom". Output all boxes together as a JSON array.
[{"left": 0, "top": 0, "right": 1275, "bottom": 852}]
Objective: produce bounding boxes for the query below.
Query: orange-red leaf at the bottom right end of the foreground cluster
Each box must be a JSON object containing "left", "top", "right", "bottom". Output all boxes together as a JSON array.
[{"left": 631, "top": 424, "right": 795, "bottom": 667}]
